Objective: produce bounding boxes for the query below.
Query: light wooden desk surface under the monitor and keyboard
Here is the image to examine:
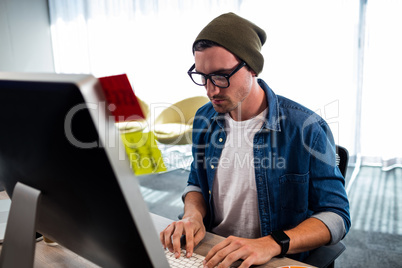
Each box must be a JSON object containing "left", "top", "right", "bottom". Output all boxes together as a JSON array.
[{"left": 0, "top": 191, "right": 311, "bottom": 268}]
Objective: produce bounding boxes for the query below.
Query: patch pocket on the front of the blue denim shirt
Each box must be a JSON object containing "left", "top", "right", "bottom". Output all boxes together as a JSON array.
[{"left": 279, "top": 172, "right": 309, "bottom": 213}]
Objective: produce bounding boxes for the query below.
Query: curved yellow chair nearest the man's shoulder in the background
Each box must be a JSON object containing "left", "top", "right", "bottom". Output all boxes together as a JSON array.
[{"left": 154, "top": 96, "right": 209, "bottom": 145}]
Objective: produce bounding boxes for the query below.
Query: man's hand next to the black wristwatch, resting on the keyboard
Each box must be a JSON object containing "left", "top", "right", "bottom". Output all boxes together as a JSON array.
[{"left": 204, "top": 236, "right": 281, "bottom": 268}]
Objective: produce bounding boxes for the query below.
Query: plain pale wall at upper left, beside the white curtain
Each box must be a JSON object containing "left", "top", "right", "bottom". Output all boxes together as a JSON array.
[{"left": 0, "top": 0, "right": 54, "bottom": 72}]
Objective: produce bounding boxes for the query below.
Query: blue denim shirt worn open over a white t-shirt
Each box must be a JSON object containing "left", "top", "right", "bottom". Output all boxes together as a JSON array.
[{"left": 185, "top": 79, "right": 351, "bottom": 252}]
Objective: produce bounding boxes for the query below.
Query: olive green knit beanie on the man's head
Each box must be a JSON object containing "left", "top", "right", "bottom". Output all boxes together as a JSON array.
[{"left": 193, "top": 13, "right": 267, "bottom": 75}]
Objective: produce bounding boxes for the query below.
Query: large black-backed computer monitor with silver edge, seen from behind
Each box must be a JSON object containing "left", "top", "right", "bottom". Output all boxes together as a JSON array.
[{"left": 0, "top": 73, "right": 168, "bottom": 267}]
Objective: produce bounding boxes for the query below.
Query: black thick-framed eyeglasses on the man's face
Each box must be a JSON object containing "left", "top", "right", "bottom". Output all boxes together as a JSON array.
[{"left": 187, "top": 61, "right": 246, "bottom": 88}]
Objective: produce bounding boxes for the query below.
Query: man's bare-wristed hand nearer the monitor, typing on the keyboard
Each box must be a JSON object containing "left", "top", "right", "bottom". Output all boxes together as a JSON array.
[{"left": 160, "top": 215, "right": 206, "bottom": 258}]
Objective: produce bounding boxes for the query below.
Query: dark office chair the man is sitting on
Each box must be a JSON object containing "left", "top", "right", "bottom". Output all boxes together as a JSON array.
[{"left": 303, "top": 145, "right": 349, "bottom": 268}]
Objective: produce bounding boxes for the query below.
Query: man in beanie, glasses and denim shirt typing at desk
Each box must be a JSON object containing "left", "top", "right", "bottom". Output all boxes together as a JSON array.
[{"left": 160, "top": 13, "right": 351, "bottom": 267}]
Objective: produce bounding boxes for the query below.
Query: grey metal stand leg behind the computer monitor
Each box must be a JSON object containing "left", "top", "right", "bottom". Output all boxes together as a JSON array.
[{"left": 0, "top": 182, "right": 41, "bottom": 268}]
